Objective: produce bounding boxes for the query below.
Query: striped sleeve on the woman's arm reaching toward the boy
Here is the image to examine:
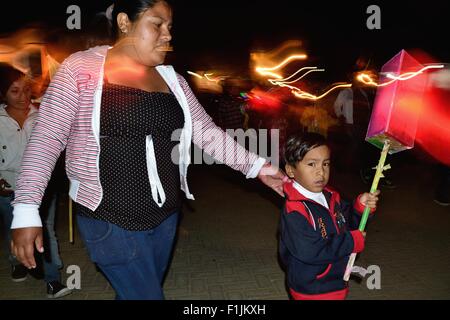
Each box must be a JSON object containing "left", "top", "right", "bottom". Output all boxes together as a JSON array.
[{"left": 177, "top": 74, "right": 266, "bottom": 178}]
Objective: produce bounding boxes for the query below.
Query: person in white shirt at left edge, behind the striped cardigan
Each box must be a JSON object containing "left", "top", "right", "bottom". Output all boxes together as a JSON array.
[{"left": 0, "top": 64, "right": 71, "bottom": 298}]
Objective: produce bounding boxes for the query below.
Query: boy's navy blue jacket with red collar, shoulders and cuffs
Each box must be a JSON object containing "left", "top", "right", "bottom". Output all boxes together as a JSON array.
[{"left": 279, "top": 182, "right": 370, "bottom": 299}]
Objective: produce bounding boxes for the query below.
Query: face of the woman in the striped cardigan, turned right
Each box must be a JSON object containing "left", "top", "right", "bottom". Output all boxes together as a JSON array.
[{"left": 127, "top": 1, "right": 172, "bottom": 66}]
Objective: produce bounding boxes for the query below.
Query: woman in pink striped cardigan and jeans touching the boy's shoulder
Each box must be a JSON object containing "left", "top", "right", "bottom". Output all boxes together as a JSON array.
[{"left": 12, "top": 0, "right": 285, "bottom": 299}]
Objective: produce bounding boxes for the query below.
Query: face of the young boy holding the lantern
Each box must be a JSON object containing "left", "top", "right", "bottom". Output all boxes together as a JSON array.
[{"left": 286, "top": 146, "right": 330, "bottom": 192}]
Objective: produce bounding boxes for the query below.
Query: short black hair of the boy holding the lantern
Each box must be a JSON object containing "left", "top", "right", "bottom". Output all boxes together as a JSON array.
[{"left": 284, "top": 132, "right": 328, "bottom": 167}]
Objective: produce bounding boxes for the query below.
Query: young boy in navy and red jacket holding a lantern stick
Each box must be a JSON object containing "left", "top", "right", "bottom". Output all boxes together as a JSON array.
[{"left": 280, "top": 133, "right": 379, "bottom": 300}]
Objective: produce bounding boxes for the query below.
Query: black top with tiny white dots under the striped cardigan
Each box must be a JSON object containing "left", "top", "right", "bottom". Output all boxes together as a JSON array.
[{"left": 76, "top": 79, "right": 184, "bottom": 231}]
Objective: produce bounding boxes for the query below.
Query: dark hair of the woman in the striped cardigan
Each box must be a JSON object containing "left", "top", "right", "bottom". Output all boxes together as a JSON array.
[{"left": 111, "top": 0, "right": 168, "bottom": 39}]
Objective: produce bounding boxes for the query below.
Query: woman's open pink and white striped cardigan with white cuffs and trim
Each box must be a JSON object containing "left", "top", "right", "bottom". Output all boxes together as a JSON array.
[{"left": 11, "top": 46, "right": 265, "bottom": 229}]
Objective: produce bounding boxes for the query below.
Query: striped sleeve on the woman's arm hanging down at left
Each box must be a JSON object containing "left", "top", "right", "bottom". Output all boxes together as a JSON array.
[{"left": 13, "top": 60, "right": 78, "bottom": 205}]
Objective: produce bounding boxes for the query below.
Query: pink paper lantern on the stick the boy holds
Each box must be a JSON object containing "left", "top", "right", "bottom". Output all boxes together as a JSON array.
[{"left": 366, "top": 50, "right": 427, "bottom": 154}]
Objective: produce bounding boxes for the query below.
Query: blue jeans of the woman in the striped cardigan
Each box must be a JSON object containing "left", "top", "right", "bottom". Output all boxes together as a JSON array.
[{"left": 77, "top": 213, "right": 178, "bottom": 300}]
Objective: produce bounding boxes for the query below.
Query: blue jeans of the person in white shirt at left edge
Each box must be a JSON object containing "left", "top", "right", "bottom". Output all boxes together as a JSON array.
[{"left": 0, "top": 194, "right": 62, "bottom": 282}]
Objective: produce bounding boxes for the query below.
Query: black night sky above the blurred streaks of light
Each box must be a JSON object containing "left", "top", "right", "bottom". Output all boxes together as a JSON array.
[{"left": 1, "top": 0, "right": 450, "bottom": 80}]
